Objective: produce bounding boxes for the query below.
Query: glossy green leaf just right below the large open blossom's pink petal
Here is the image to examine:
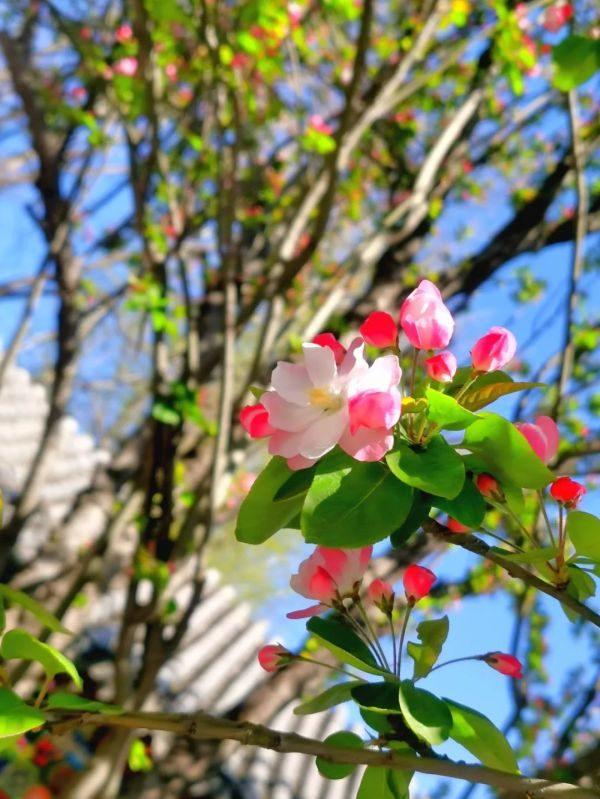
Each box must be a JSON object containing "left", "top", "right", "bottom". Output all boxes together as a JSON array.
[{"left": 386, "top": 436, "right": 465, "bottom": 499}]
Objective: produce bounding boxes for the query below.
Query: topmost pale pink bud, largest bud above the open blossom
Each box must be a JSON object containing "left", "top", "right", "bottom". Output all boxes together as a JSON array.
[{"left": 400, "top": 280, "right": 454, "bottom": 350}]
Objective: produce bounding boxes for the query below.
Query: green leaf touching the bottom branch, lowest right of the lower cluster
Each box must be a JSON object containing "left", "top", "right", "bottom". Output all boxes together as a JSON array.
[{"left": 444, "top": 699, "right": 519, "bottom": 774}]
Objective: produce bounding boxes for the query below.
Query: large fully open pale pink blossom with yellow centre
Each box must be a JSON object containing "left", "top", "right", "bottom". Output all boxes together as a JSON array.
[{"left": 262, "top": 339, "right": 401, "bottom": 468}]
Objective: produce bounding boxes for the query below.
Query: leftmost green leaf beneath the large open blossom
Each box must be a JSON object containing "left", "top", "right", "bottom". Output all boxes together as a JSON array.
[{"left": 235, "top": 457, "right": 304, "bottom": 544}]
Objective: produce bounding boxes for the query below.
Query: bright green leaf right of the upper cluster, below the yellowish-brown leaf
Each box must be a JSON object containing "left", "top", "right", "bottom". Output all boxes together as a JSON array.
[{"left": 462, "top": 413, "right": 552, "bottom": 489}]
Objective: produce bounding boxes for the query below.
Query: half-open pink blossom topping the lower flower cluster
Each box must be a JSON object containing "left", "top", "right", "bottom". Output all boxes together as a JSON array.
[{"left": 287, "top": 547, "right": 373, "bottom": 619}]
